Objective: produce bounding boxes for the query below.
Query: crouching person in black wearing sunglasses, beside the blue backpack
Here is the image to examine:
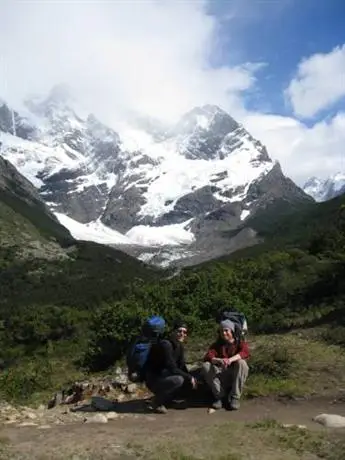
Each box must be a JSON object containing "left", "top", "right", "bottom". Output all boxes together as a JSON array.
[{"left": 145, "top": 322, "right": 196, "bottom": 414}]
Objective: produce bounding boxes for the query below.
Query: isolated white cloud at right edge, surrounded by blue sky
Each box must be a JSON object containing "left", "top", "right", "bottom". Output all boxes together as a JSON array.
[{"left": 286, "top": 44, "right": 345, "bottom": 118}]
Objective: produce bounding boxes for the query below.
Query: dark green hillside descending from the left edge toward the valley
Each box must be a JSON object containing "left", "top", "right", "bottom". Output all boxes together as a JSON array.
[{"left": 0, "top": 171, "right": 162, "bottom": 372}]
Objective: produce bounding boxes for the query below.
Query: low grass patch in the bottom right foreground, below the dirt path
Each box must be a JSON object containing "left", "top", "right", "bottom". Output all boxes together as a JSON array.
[{"left": 127, "top": 420, "right": 345, "bottom": 460}]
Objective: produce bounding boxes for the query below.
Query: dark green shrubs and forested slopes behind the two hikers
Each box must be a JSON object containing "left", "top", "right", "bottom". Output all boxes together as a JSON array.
[{"left": 0, "top": 158, "right": 345, "bottom": 402}]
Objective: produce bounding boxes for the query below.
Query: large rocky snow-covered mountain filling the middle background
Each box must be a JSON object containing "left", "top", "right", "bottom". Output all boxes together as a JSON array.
[{"left": 0, "top": 86, "right": 310, "bottom": 266}]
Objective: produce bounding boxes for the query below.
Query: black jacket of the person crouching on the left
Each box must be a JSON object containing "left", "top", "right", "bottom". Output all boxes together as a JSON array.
[{"left": 146, "top": 337, "right": 192, "bottom": 380}]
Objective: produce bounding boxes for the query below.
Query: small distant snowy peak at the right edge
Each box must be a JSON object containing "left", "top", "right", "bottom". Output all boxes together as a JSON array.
[{"left": 303, "top": 172, "right": 345, "bottom": 202}]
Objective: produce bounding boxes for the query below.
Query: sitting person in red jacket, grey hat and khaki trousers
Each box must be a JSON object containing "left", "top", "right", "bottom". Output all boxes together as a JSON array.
[{"left": 202, "top": 319, "right": 249, "bottom": 410}]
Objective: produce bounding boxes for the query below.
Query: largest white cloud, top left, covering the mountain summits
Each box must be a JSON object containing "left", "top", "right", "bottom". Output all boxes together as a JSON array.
[{"left": 0, "top": 0, "right": 258, "bottom": 120}]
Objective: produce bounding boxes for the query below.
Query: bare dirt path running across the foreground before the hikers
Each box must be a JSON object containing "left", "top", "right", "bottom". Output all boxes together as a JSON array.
[{"left": 1, "top": 399, "right": 345, "bottom": 459}]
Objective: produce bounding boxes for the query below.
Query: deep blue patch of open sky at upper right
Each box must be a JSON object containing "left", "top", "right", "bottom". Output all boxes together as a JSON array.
[{"left": 210, "top": 0, "right": 345, "bottom": 120}]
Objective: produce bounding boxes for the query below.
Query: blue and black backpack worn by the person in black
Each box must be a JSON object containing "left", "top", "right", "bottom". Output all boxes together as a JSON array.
[{"left": 127, "top": 316, "right": 165, "bottom": 382}]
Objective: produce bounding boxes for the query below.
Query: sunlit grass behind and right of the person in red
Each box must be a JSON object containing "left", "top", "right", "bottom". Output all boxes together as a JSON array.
[{"left": 187, "top": 328, "right": 345, "bottom": 398}]
